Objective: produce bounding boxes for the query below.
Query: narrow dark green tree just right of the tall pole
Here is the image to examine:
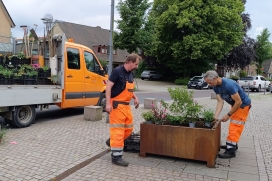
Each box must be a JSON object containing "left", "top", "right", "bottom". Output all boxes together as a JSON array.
[{"left": 113, "top": 0, "right": 152, "bottom": 53}]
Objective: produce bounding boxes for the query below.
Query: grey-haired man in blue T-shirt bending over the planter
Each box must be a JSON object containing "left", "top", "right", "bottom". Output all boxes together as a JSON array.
[{"left": 204, "top": 71, "right": 251, "bottom": 158}]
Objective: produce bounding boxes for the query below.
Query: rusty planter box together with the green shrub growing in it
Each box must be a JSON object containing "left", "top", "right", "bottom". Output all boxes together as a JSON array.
[{"left": 140, "top": 88, "right": 221, "bottom": 167}]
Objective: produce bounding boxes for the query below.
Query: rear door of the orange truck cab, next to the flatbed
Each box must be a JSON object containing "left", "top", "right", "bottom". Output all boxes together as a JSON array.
[{"left": 62, "top": 47, "right": 84, "bottom": 108}]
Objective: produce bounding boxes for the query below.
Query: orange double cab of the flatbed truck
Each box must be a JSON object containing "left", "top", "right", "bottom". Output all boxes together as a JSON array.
[{"left": 57, "top": 42, "right": 107, "bottom": 108}]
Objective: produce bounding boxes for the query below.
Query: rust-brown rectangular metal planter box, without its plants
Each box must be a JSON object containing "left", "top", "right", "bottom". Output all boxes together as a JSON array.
[{"left": 140, "top": 123, "right": 221, "bottom": 168}]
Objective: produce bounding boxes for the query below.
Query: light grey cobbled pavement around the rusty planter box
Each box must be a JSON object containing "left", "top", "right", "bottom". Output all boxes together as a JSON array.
[{"left": 0, "top": 94, "right": 272, "bottom": 181}]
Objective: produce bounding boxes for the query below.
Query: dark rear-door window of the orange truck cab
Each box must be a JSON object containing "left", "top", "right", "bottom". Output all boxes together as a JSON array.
[{"left": 67, "top": 48, "right": 80, "bottom": 69}]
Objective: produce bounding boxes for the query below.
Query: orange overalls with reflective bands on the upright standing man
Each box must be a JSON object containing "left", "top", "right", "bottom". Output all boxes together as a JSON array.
[{"left": 110, "top": 81, "right": 134, "bottom": 156}]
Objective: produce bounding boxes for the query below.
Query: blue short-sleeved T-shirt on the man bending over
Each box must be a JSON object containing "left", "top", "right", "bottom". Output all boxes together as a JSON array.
[{"left": 213, "top": 78, "right": 251, "bottom": 108}]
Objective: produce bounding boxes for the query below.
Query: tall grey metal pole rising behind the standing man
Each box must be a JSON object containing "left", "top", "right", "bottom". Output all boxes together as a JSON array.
[{"left": 106, "top": 0, "right": 114, "bottom": 123}]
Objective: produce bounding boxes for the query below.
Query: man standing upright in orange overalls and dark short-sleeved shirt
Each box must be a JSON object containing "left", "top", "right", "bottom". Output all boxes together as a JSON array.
[{"left": 106, "top": 54, "right": 141, "bottom": 166}]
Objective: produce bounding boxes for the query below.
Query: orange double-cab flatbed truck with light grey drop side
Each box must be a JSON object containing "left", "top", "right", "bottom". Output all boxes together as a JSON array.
[{"left": 0, "top": 34, "right": 108, "bottom": 128}]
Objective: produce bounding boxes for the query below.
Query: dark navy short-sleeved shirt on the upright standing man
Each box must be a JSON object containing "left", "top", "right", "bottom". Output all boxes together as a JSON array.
[{"left": 109, "top": 65, "right": 134, "bottom": 98}]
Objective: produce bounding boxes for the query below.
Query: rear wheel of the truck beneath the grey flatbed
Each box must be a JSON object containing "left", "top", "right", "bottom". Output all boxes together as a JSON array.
[{"left": 12, "top": 106, "right": 36, "bottom": 128}]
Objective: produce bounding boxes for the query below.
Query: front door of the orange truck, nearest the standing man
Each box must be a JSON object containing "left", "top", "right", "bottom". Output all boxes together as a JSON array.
[{"left": 84, "top": 50, "right": 106, "bottom": 105}]
